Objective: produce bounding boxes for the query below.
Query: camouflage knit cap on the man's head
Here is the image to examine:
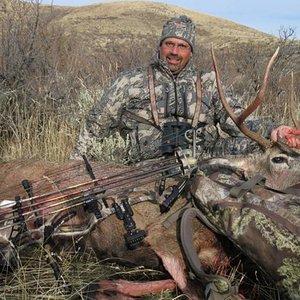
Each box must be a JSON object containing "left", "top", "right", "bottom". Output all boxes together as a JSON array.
[{"left": 159, "top": 16, "right": 195, "bottom": 50}]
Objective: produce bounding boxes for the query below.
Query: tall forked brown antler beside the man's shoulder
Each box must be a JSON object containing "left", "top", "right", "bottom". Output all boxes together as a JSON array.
[{"left": 211, "top": 46, "right": 279, "bottom": 148}]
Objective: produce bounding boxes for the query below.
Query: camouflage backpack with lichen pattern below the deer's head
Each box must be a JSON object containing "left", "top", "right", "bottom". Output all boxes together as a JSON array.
[{"left": 192, "top": 170, "right": 300, "bottom": 299}]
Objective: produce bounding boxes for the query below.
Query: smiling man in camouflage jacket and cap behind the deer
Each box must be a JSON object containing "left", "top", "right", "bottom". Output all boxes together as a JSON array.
[{"left": 72, "top": 16, "right": 295, "bottom": 162}]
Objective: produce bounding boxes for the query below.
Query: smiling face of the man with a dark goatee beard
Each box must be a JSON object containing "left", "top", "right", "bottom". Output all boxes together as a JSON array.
[{"left": 159, "top": 38, "right": 192, "bottom": 75}]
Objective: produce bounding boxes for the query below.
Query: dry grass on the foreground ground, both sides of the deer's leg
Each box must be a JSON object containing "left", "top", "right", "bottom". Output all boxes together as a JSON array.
[{"left": 0, "top": 246, "right": 280, "bottom": 300}]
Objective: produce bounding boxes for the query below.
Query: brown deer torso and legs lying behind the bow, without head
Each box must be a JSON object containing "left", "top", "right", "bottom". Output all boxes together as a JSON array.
[{"left": 0, "top": 161, "right": 225, "bottom": 299}]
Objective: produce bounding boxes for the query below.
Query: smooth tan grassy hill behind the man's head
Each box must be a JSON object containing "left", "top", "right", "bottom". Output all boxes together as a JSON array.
[{"left": 43, "top": 1, "right": 277, "bottom": 48}]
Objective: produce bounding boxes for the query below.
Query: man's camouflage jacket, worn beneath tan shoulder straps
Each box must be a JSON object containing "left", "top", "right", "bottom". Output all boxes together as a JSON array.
[{"left": 72, "top": 59, "right": 273, "bottom": 162}]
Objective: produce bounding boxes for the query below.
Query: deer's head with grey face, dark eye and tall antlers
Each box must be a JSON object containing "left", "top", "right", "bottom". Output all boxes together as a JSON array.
[{"left": 209, "top": 48, "right": 300, "bottom": 189}]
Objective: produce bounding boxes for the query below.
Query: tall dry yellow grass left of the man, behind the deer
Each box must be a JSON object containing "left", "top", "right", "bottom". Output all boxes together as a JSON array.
[{"left": 0, "top": 88, "right": 102, "bottom": 161}]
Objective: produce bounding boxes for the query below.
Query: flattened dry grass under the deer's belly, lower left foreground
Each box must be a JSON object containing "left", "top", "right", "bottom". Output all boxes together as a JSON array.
[{"left": 0, "top": 247, "right": 176, "bottom": 300}]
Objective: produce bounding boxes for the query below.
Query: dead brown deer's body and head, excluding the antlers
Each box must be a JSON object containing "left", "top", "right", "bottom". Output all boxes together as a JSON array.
[{"left": 0, "top": 144, "right": 300, "bottom": 299}]
